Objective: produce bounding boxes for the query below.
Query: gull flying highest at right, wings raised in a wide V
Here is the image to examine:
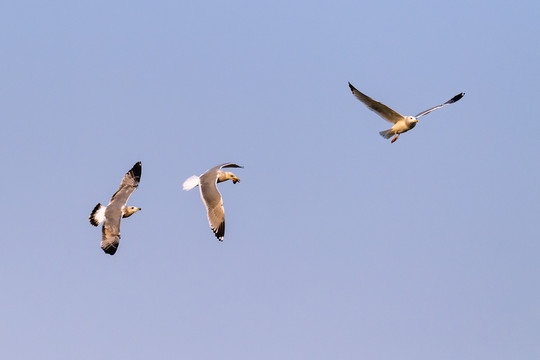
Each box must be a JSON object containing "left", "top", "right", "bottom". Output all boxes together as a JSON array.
[{"left": 349, "top": 83, "right": 465, "bottom": 142}]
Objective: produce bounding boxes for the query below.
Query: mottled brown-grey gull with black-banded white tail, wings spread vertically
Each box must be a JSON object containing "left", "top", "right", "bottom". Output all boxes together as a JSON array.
[{"left": 89, "top": 161, "right": 142, "bottom": 255}]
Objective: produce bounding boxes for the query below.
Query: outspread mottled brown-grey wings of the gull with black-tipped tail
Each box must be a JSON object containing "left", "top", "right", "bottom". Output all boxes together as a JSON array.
[{"left": 101, "top": 161, "right": 142, "bottom": 255}]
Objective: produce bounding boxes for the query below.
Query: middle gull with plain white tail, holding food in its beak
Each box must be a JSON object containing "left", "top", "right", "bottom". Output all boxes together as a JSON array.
[{"left": 182, "top": 163, "right": 243, "bottom": 241}]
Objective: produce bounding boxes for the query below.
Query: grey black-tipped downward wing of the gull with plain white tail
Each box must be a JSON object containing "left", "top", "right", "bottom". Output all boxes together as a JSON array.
[{"left": 199, "top": 168, "right": 226, "bottom": 241}]
